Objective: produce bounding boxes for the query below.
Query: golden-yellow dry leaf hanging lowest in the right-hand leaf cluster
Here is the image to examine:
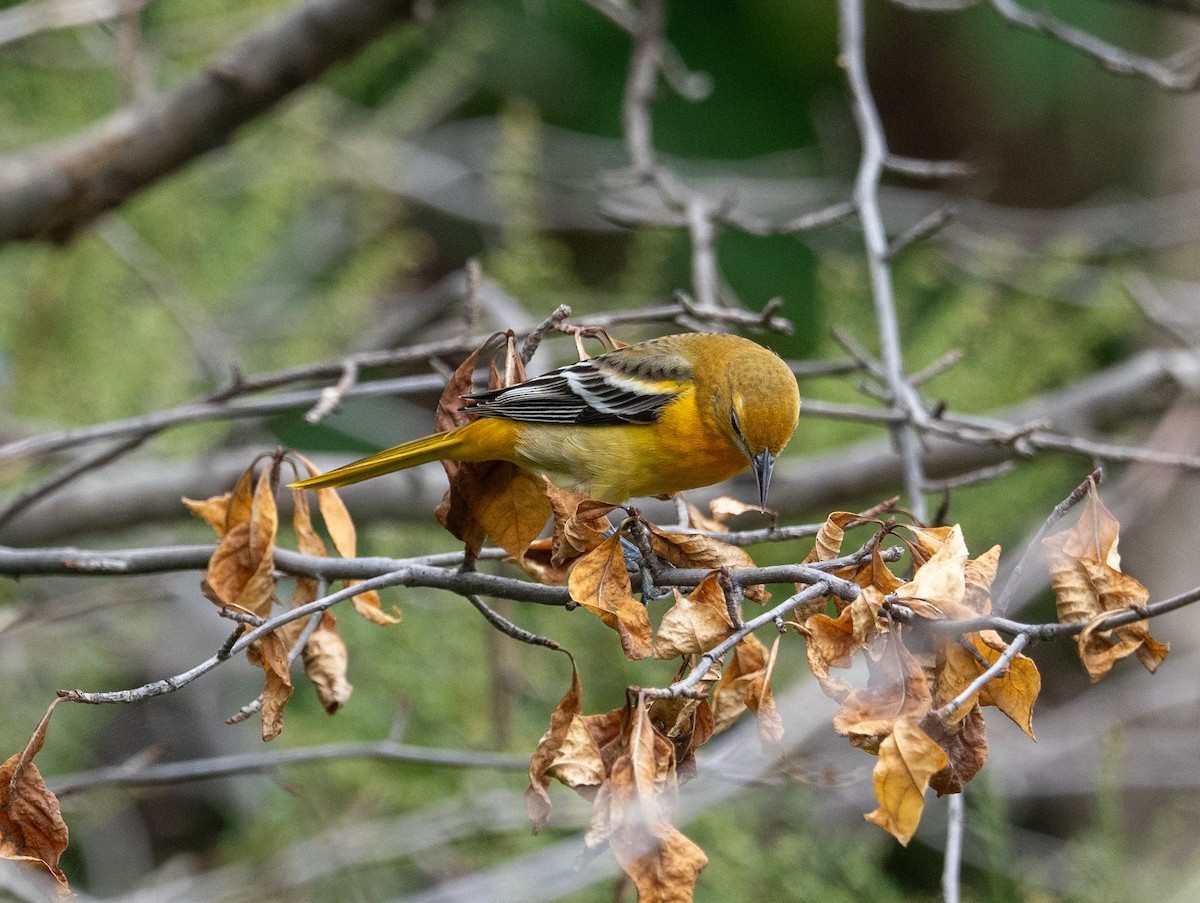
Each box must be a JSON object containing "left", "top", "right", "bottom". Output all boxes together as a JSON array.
[{"left": 864, "top": 717, "right": 949, "bottom": 847}]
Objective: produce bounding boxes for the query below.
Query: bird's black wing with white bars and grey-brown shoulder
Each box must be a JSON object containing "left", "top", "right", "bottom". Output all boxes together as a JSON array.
[{"left": 463, "top": 342, "right": 691, "bottom": 426}]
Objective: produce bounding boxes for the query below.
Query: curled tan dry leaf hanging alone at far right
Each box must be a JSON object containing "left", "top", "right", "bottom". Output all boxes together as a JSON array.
[{"left": 1042, "top": 484, "right": 1170, "bottom": 683}]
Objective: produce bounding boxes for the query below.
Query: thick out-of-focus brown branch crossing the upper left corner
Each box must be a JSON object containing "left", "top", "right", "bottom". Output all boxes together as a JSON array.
[{"left": 0, "top": 0, "right": 446, "bottom": 243}]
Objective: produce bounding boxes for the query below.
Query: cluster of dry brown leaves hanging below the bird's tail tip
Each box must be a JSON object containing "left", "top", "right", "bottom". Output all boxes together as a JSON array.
[{"left": 184, "top": 453, "right": 398, "bottom": 740}]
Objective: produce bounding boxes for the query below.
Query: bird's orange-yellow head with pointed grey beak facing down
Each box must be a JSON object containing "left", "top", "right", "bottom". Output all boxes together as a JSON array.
[{"left": 716, "top": 346, "right": 800, "bottom": 506}]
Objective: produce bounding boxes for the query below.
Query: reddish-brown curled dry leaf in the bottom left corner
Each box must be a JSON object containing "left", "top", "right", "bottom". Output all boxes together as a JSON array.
[{"left": 0, "top": 699, "right": 70, "bottom": 897}]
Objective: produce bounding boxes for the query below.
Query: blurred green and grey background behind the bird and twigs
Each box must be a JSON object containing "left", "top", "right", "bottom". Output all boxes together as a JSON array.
[{"left": 0, "top": 0, "right": 1200, "bottom": 903}]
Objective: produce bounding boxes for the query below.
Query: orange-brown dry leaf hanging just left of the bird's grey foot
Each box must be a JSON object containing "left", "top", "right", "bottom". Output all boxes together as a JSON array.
[{"left": 566, "top": 532, "right": 654, "bottom": 659}]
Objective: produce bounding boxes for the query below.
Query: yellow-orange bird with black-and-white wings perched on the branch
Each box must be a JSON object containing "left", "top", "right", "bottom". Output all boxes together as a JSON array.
[{"left": 285, "top": 333, "right": 800, "bottom": 507}]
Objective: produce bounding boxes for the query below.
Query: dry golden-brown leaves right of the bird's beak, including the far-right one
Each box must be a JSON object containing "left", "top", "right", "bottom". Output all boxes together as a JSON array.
[{"left": 794, "top": 485, "right": 1168, "bottom": 843}]
